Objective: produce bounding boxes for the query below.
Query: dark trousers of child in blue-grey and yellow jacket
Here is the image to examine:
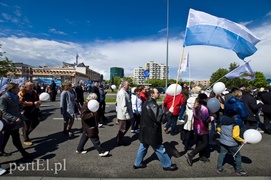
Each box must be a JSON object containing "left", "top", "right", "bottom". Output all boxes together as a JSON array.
[{"left": 217, "top": 144, "right": 242, "bottom": 172}]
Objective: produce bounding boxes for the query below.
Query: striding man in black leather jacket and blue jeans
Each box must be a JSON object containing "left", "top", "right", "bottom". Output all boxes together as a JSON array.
[{"left": 134, "top": 88, "right": 178, "bottom": 171}]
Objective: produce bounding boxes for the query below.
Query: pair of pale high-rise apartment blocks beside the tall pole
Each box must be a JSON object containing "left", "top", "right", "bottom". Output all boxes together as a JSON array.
[{"left": 134, "top": 61, "right": 169, "bottom": 84}]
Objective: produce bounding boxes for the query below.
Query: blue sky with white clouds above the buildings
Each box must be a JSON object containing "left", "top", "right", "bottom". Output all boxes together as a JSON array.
[{"left": 0, "top": 0, "right": 271, "bottom": 80}]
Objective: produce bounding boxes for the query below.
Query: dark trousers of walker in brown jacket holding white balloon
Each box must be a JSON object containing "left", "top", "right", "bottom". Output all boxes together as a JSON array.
[{"left": 77, "top": 133, "right": 104, "bottom": 153}]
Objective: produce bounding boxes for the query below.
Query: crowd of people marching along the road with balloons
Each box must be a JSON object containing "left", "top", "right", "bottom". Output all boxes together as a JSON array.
[{"left": 0, "top": 81, "right": 271, "bottom": 175}]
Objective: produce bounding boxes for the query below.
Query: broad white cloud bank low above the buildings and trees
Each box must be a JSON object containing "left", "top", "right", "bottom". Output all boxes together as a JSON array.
[{"left": 0, "top": 21, "right": 271, "bottom": 80}]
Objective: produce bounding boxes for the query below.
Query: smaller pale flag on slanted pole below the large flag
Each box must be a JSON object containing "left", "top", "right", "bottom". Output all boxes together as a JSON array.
[{"left": 225, "top": 62, "right": 255, "bottom": 80}]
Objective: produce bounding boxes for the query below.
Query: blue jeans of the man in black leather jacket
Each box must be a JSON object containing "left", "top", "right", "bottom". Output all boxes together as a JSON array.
[{"left": 134, "top": 143, "right": 171, "bottom": 168}]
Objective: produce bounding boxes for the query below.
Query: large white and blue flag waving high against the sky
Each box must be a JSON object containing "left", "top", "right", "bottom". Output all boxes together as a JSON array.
[{"left": 184, "top": 9, "right": 260, "bottom": 59}]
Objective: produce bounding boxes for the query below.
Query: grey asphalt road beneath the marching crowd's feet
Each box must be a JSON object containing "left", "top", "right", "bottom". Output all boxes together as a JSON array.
[{"left": 0, "top": 93, "right": 271, "bottom": 179}]
